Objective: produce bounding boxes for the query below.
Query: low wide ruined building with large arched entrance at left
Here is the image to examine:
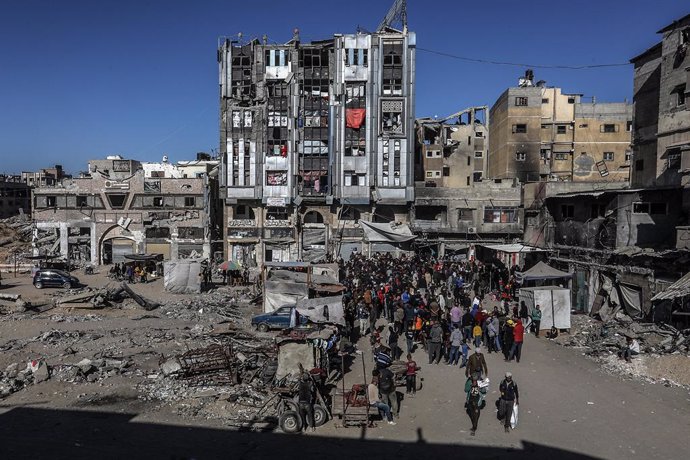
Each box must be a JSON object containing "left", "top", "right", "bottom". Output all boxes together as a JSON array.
[{"left": 32, "top": 156, "right": 216, "bottom": 265}]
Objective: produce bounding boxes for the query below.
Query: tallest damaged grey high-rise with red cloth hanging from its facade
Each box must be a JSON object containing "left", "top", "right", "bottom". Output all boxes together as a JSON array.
[{"left": 218, "top": 2, "right": 415, "bottom": 266}]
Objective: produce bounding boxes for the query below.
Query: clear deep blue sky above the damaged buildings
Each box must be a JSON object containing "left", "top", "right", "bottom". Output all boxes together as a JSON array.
[{"left": 0, "top": 0, "right": 689, "bottom": 173}]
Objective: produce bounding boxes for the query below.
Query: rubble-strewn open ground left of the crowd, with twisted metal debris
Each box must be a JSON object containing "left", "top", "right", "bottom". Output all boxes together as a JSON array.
[{"left": 0, "top": 272, "right": 275, "bottom": 425}]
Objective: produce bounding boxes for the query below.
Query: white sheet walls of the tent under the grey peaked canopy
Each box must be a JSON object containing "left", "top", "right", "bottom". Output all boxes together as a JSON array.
[{"left": 520, "top": 286, "right": 570, "bottom": 330}]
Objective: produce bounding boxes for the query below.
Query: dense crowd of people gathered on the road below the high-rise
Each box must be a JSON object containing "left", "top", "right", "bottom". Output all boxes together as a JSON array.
[{"left": 340, "top": 254, "right": 541, "bottom": 435}]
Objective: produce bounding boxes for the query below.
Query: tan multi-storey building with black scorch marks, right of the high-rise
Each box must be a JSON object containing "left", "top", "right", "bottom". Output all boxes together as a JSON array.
[{"left": 488, "top": 70, "right": 632, "bottom": 183}]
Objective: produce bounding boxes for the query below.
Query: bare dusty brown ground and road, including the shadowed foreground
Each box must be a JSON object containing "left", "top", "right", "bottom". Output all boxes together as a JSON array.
[{"left": 0, "top": 275, "right": 690, "bottom": 459}]
